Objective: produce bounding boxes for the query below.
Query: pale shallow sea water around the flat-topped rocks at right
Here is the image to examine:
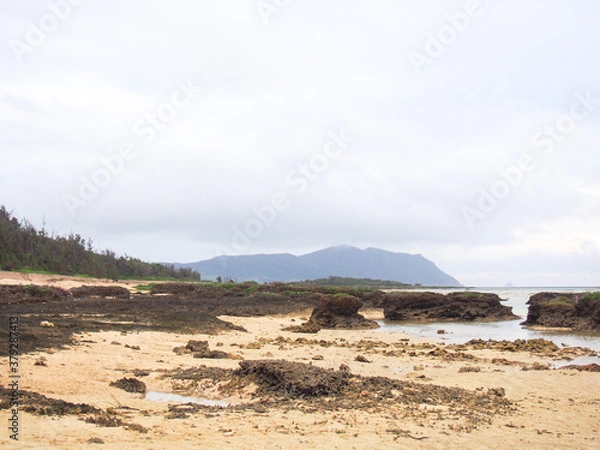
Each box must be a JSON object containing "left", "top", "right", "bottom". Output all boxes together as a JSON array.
[{"left": 378, "top": 287, "right": 600, "bottom": 363}]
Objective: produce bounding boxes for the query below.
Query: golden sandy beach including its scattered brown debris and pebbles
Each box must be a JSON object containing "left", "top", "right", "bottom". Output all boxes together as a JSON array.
[{"left": 0, "top": 275, "right": 600, "bottom": 449}]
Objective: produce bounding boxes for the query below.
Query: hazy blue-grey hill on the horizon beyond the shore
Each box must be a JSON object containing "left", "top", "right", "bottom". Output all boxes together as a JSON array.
[{"left": 175, "top": 246, "right": 461, "bottom": 286}]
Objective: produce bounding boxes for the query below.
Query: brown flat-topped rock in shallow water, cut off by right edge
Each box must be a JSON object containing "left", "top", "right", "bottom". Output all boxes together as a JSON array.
[{"left": 522, "top": 292, "right": 600, "bottom": 331}]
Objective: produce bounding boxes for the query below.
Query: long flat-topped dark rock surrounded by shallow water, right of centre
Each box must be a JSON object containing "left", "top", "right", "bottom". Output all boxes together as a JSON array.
[{"left": 383, "top": 292, "right": 518, "bottom": 322}]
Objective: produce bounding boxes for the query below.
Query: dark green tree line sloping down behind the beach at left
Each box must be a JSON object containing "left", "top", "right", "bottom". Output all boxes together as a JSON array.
[{"left": 0, "top": 206, "right": 200, "bottom": 280}]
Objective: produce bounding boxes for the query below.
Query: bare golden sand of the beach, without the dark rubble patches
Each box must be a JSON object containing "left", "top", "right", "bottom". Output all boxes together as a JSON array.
[{"left": 0, "top": 274, "right": 600, "bottom": 450}]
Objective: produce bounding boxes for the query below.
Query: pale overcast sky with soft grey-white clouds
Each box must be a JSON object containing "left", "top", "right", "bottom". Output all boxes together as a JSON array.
[{"left": 0, "top": 0, "right": 600, "bottom": 286}]
